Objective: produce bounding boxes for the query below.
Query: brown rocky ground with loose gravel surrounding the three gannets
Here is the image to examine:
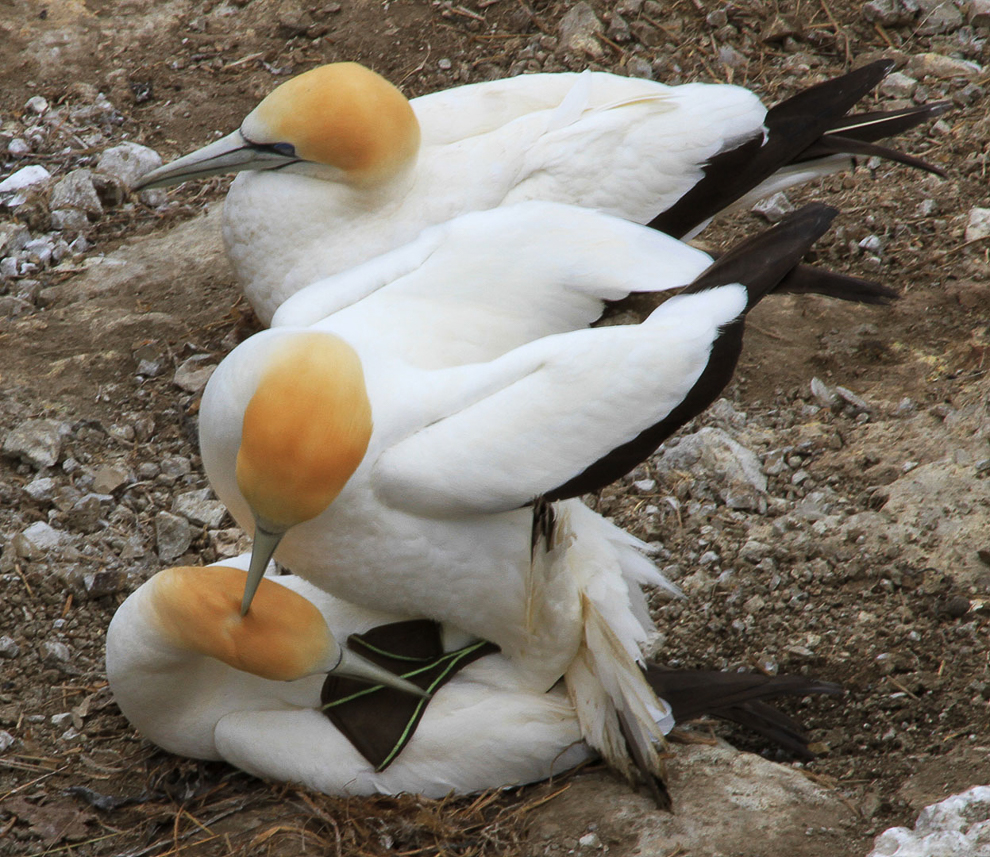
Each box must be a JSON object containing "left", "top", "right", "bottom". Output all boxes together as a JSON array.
[{"left": 0, "top": 0, "right": 990, "bottom": 855}]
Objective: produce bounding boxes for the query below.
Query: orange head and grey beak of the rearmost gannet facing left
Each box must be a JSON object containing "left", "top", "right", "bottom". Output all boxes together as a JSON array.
[{"left": 133, "top": 62, "right": 419, "bottom": 190}]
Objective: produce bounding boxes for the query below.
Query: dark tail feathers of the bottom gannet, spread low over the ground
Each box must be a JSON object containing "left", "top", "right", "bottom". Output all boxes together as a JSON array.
[{"left": 645, "top": 664, "right": 843, "bottom": 759}]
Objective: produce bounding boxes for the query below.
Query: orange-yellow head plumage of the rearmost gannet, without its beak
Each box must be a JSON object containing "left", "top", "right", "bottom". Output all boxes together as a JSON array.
[{"left": 241, "top": 62, "right": 420, "bottom": 184}]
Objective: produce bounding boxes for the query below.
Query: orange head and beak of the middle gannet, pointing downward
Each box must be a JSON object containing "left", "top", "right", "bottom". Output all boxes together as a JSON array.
[{"left": 237, "top": 331, "right": 372, "bottom": 612}]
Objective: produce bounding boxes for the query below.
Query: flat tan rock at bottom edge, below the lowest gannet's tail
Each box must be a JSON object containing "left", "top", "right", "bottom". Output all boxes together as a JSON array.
[{"left": 524, "top": 745, "right": 854, "bottom": 857}]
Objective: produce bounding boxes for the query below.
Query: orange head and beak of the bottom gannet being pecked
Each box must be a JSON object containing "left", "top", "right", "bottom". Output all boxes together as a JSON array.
[{"left": 148, "top": 566, "right": 425, "bottom": 696}]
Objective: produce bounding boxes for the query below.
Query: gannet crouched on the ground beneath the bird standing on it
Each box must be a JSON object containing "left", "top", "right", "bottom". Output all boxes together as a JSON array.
[{"left": 106, "top": 555, "right": 839, "bottom": 798}]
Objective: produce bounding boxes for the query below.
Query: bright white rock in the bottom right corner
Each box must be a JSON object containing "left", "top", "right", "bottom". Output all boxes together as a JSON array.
[{"left": 868, "top": 786, "right": 990, "bottom": 857}]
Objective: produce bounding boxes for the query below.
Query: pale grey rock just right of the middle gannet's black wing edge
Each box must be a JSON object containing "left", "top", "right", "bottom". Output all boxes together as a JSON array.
[{"left": 656, "top": 427, "right": 767, "bottom": 513}]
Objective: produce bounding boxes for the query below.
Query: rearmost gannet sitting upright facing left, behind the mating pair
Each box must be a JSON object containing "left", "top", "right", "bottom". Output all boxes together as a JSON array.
[{"left": 135, "top": 60, "right": 946, "bottom": 324}]
